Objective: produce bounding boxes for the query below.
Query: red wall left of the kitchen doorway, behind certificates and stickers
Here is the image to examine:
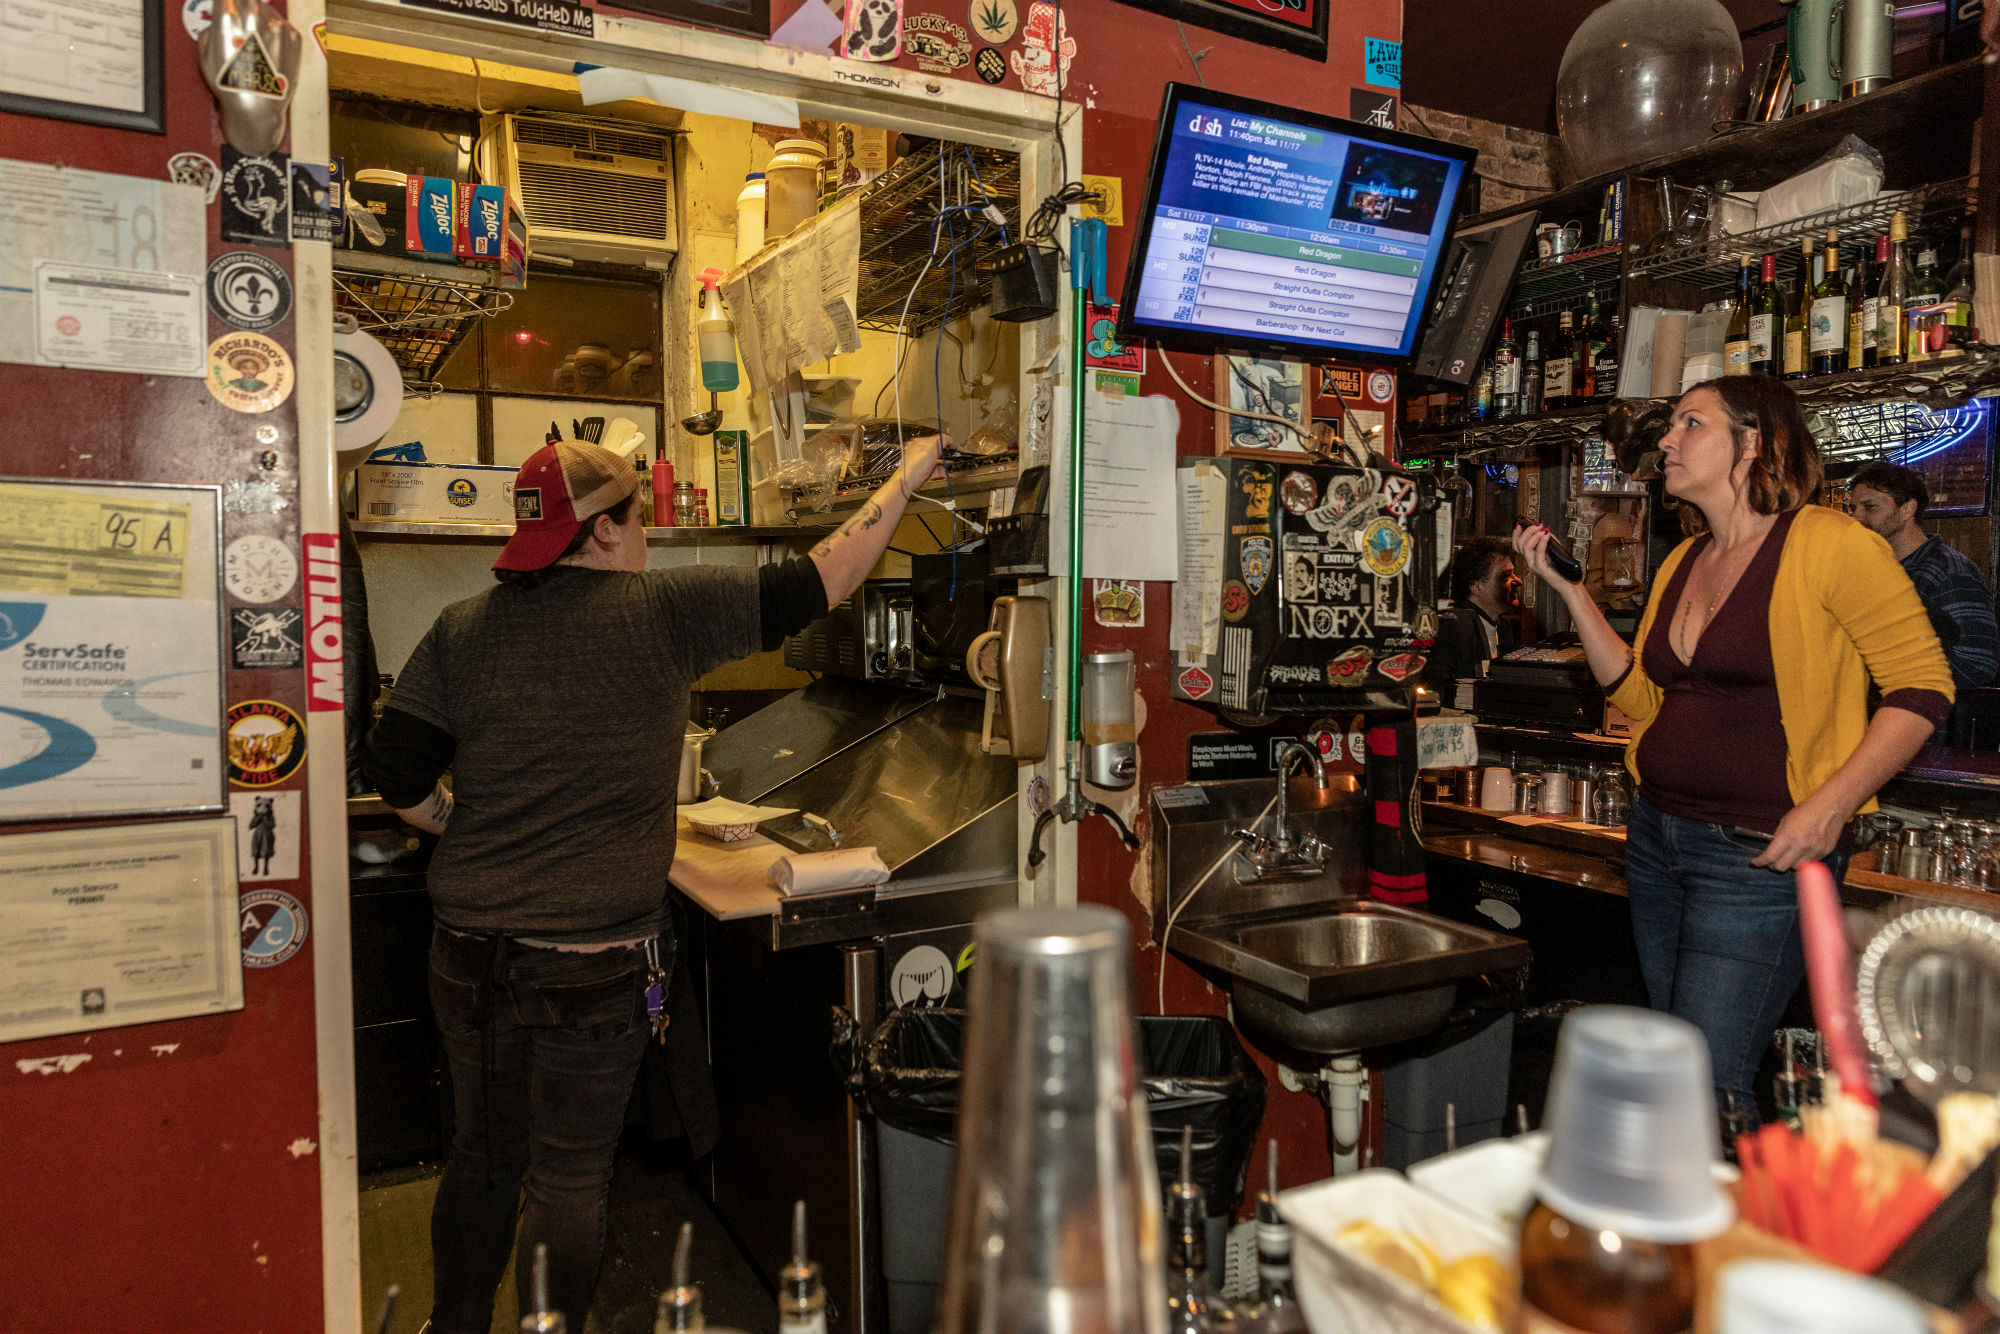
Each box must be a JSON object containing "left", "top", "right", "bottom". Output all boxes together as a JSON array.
[{"left": 0, "top": 0, "right": 328, "bottom": 1330}]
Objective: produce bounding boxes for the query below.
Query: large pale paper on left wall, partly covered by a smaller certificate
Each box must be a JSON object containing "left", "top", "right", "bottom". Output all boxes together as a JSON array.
[{"left": 0, "top": 158, "right": 208, "bottom": 362}]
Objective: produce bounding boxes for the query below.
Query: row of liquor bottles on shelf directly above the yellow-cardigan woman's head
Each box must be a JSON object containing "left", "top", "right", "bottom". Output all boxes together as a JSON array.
[{"left": 1722, "top": 214, "right": 1972, "bottom": 380}]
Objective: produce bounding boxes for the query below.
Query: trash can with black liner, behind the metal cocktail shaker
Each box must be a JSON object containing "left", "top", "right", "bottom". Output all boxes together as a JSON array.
[{"left": 862, "top": 1008, "right": 1264, "bottom": 1334}]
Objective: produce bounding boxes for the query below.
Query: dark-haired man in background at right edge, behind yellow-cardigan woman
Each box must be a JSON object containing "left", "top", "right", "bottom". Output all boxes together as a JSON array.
[{"left": 1848, "top": 458, "right": 2000, "bottom": 690}]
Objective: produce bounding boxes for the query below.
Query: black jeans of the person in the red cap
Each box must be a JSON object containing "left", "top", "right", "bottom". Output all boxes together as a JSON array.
[{"left": 430, "top": 930, "right": 650, "bottom": 1334}]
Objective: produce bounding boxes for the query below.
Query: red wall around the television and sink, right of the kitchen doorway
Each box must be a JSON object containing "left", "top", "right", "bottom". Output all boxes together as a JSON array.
[{"left": 772, "top": 0, "right": 1402, "bottom": 1186}]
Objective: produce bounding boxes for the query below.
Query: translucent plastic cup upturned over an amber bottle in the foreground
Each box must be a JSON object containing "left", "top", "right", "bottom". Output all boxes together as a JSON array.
[{"left": 1534, "top": 1006, "right": 1736, "bottom": 1246}]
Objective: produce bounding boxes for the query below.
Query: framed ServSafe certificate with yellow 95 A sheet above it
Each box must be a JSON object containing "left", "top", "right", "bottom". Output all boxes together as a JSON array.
[{"left": 0, "top": 478, "right": 228, "bottom": 824}]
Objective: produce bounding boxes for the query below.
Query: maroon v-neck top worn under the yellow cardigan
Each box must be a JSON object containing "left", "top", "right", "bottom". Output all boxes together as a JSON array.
[{"left": 1638, "top": 510, "right": 1798, "bottom": 834}]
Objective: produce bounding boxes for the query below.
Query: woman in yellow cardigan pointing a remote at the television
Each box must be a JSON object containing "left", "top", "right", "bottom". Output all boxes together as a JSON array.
[{"left": 1514, "top": 376, "right": 1952, "bottom": 1124}]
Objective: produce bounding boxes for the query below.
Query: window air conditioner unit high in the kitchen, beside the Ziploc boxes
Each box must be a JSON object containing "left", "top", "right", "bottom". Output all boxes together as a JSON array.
[{"left": 478, "top": 112, "right": 680, "bottom": 268}]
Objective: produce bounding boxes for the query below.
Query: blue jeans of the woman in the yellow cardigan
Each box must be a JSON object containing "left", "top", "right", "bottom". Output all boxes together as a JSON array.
[{"left": 1626, "top": 794, "right": 1848, "bottom": 1128}]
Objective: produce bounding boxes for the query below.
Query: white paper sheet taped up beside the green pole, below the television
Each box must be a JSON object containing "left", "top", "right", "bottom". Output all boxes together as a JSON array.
[{"left": 1060, "top": 394, "right": 1180, "bottom": 580}]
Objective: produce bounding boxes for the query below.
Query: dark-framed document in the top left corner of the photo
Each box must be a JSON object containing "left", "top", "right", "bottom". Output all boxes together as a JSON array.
[{"left": 0, "top": 0, "right": 166, "bottom": 134}]
